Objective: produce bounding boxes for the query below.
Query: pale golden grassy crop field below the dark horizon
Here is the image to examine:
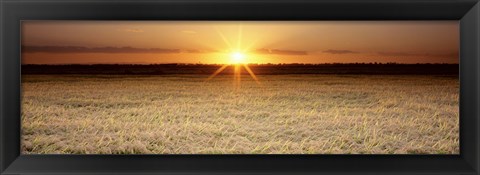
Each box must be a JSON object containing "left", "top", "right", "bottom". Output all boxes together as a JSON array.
[{"left": 21, "top": 75, "right": 459, "bottom": 154}]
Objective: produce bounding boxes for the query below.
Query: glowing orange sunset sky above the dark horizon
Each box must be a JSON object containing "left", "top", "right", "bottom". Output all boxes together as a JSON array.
[{"left": 22, "top": 21, "right": 459, "bottom": 64}]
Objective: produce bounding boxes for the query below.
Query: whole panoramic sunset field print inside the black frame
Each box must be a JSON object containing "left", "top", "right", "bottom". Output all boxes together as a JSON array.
[{"left": 21, "top": 21, "right": 459, "bottom": 154}]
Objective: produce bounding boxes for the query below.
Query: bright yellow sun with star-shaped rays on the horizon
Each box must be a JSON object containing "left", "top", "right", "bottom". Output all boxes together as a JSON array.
[{"left": 206, "top": 25, "right": 260, "bottom": 88}]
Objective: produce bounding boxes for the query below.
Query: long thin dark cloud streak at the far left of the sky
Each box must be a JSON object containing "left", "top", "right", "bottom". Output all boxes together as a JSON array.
[{"left": 22, "top": 46, "right": 180, "bottom": 53}]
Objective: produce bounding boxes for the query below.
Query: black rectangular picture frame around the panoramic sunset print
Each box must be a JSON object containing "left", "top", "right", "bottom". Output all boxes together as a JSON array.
[{"left": 0, "top": 0, "right": 480, "bottom": 175}]
